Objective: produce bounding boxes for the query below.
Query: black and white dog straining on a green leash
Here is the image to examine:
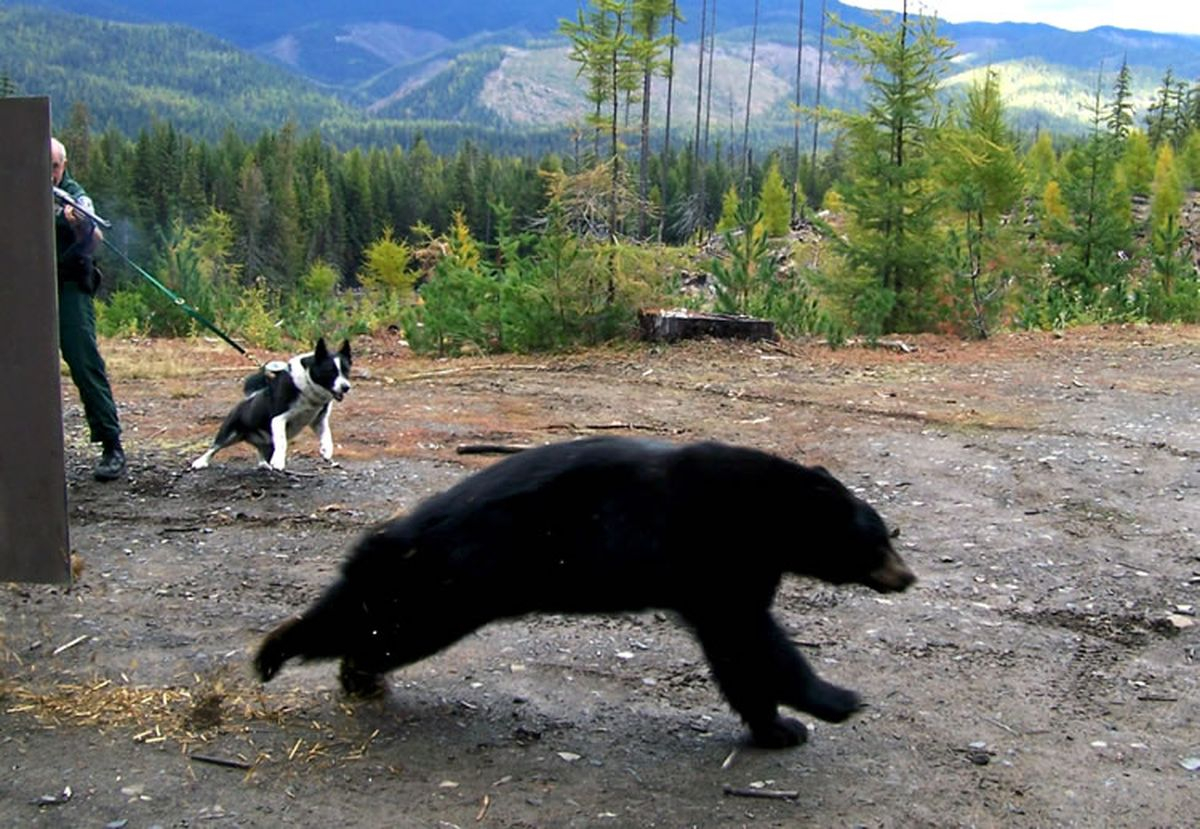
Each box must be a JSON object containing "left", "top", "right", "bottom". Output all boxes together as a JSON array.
[{"left": 192, "top": 337, "right": 350, "bottom": 469}]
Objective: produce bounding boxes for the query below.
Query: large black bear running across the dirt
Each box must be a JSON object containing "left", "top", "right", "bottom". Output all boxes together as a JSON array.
[{"left": 254, "top": 438, "right": 916, "bottom": 747}]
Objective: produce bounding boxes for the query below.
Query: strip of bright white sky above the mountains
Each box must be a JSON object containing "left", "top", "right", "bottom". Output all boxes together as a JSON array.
[{"left": 842, "top": 0, "right": 1200, "bottom": 35}]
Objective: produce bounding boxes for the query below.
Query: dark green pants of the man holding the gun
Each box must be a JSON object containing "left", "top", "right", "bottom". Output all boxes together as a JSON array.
[{"left": 59, "top": 282, "right": 121, "bottom": 444}]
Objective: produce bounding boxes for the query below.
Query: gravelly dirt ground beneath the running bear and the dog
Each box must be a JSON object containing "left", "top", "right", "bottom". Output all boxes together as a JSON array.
[{"left": 0, "top": 328, "right": 1200, "bottom": 828}]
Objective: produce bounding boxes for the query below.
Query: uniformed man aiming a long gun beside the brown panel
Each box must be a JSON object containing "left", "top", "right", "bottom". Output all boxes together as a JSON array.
[{"left": 50, "top": 138, "right": 126, "bottom": 481}]
